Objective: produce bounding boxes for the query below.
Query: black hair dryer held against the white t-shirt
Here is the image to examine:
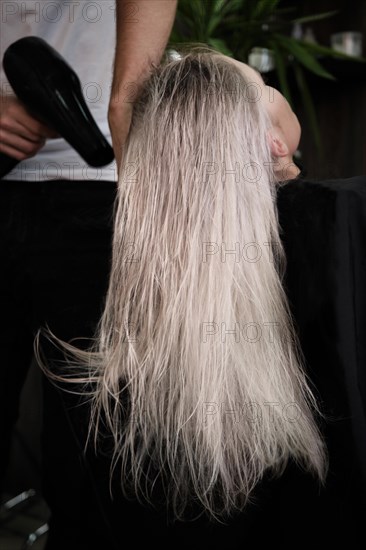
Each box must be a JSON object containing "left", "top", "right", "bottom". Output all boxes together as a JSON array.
[{"left": 0, "top": 36, "right": 114, "bottom": 178}]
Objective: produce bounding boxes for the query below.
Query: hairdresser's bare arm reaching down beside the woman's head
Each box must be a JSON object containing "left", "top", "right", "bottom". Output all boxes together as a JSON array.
[{"left": 108, "top": 0, "right": 177, "bottom": 167}]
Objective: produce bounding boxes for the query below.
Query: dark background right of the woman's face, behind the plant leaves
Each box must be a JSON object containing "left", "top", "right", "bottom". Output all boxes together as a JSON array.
[{"left": 283, "top": 0, "right": 366, "bottom": 179}]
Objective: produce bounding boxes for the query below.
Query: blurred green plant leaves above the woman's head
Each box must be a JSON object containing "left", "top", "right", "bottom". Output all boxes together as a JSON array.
[{"left": 169, "top": 0, "right": 365, "bottom": 152}]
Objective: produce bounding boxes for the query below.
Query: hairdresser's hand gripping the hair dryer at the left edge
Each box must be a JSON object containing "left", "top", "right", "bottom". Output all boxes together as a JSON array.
[{"left": 0, "top": 95, "right": 58, "bottom": 160}]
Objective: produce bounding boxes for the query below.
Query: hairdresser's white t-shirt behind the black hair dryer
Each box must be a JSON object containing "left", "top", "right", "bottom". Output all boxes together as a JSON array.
[{"left": 0, "top": 0, "right": 117, "bottom": 181}]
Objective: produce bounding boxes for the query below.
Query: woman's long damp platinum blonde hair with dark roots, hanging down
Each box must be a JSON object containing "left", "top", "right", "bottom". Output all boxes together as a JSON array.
[{"left": 43, "top": 49, "right": 326, "bottom": 519}]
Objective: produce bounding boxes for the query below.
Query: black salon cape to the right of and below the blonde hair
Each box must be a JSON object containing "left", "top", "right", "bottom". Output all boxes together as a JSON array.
[{"left": 62, "top": 176, "right": 366, "bottom": 550}]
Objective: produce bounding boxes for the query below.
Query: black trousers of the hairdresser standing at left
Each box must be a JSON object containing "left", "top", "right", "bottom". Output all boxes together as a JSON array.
[{"left": 0, "top": 180, "right": 116, "bottom": 550}]
